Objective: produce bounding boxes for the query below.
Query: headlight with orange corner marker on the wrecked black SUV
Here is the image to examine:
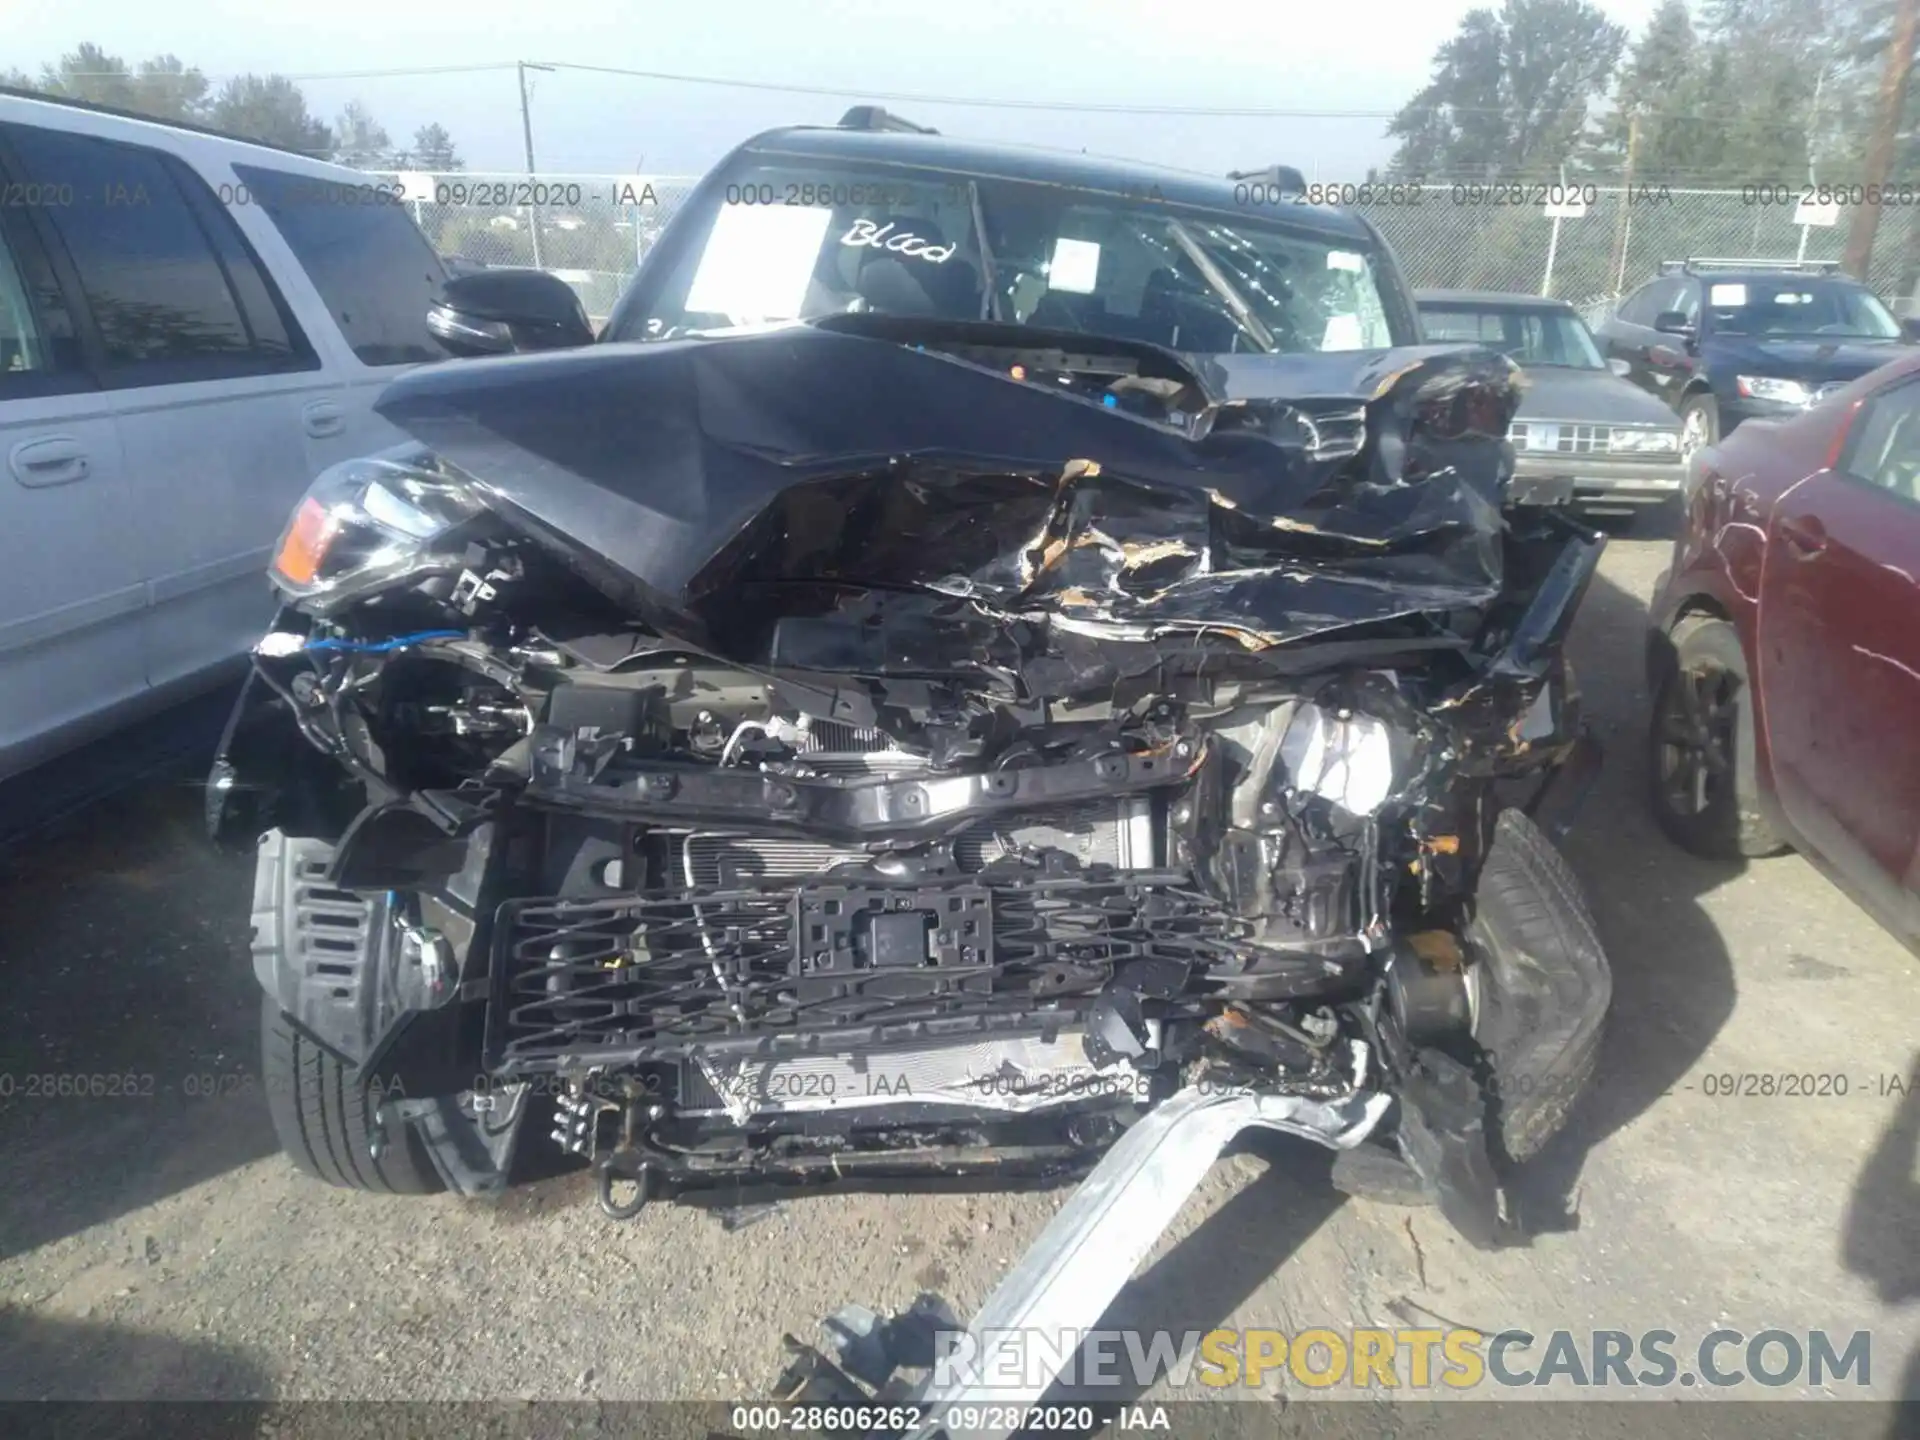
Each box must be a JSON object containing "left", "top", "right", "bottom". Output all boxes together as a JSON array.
[{"left": 269, "top": 449, "right": 486, "bottom": 614}]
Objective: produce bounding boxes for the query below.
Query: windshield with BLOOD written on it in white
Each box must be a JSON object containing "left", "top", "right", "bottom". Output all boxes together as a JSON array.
[{"left": 609, "top": 161, "right": 1394, "bottom": 353}]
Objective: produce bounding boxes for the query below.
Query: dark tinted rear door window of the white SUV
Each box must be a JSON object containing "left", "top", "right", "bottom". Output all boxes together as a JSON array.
[{"left": 6, "top": 125, "right": 309, "bottom": 386}]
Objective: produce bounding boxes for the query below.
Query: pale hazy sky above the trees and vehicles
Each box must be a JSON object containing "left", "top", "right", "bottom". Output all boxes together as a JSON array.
[{"left": 0, "top": 0, "right": 1657, "bottom": 180}]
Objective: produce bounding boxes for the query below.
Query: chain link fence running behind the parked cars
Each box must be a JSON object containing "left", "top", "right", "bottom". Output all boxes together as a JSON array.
[{"left": 382, "top": 173, "right": 1920, "bottom": 323}]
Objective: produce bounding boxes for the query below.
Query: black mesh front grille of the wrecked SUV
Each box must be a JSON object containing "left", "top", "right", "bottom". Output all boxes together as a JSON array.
[{"left": 486, "top": 868, "right": 1244, "bottom": 1077}]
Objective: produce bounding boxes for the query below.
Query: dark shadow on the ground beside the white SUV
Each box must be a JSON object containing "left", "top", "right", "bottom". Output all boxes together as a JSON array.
[{"left": 0, "top": 780, "right": 276, "bottom": 1256}]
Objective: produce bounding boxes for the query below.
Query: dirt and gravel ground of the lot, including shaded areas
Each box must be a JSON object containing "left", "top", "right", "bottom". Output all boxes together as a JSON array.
[{"left": 0, "top": 540, "right": 1920, "bottom": 1432}]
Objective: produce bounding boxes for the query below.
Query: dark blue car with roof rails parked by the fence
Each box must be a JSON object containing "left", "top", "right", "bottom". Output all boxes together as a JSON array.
[{"left": 1599, "top": 259, "right": 1910, "bottom": 455}]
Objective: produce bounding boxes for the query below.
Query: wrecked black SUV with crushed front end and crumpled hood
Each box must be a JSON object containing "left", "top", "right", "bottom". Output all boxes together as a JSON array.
[{"left": 207, "top": 117, "right": 1609, "bottom": 1242}]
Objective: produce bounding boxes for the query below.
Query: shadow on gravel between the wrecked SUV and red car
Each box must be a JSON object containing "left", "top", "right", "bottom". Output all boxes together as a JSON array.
[{"left": 1515, "top": 568, "right": 1741, "bottom": 1233}]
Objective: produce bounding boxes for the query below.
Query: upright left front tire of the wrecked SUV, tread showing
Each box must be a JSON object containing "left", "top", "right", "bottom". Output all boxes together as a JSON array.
[{"left": 259, "top": 995, "right": 445, "bottom": 1194}]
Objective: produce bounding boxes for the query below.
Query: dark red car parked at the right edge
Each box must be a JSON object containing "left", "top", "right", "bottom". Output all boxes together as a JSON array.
[{"left": 1647, "top": 355, "right": 1920, "bottom": 952}]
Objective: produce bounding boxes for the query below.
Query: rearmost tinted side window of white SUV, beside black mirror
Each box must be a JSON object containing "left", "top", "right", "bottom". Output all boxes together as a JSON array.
[{"left": 234, "top": 165, "right": 445, "bottom": 365}]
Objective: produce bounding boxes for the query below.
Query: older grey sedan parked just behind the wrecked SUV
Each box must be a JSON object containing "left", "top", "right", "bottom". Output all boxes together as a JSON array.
[{"left": 1415, "top": 290, "right": 1684, "bottom": 513}]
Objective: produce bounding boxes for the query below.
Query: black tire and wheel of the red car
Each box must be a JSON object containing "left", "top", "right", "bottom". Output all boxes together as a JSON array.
[{"left": 1647, "top": 614, "right": 1788, "bottom": 860}]
